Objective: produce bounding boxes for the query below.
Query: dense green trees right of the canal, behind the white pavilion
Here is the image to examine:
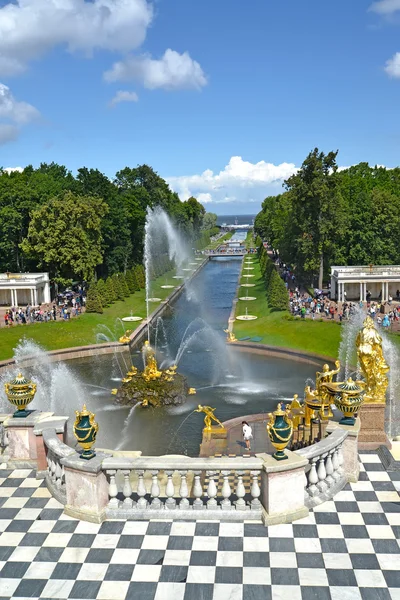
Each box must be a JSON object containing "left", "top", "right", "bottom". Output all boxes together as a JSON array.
[{"left": 255, "top": 148, "right": 400, "bottom": 288}]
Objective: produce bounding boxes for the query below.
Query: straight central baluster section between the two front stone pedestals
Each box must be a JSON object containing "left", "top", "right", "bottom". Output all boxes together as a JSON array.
[{"left": 102, "top": 456, "right": 263, "bottom": 520}]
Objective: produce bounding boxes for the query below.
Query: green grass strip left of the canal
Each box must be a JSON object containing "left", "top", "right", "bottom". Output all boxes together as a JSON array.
[{"left": 0, "top": 263, "right": 201, "bottom": 360}]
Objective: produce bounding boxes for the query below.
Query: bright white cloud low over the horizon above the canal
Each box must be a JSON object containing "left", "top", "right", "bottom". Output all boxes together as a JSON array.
[{"left": 168, "top": 156, "right": 296, "bottom": 204}]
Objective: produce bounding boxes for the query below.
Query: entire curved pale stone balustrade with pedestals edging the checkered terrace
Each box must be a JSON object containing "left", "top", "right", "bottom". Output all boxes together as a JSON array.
[{"left": 0, "top": 413, "right": 359, "bottom": 525}]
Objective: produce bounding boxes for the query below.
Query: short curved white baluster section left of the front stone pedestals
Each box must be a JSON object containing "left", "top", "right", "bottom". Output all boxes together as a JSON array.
[{"left": 42, "top": 429, "right": 77, "bottom": 505}]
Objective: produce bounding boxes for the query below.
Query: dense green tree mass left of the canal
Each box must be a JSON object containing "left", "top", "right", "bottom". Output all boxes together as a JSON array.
[{"left": 0, "top": 163, "right": 216, "bottom": 286}]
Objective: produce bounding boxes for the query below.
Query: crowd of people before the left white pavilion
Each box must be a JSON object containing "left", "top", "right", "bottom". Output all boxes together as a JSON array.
[{"left": 4, "top": 293, "right": 86, "bottom": 327}]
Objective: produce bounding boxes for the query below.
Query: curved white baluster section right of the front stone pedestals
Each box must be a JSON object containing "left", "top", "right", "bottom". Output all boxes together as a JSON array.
[{"left": 296, "top": 429, "right": 348, "bottom": 508}]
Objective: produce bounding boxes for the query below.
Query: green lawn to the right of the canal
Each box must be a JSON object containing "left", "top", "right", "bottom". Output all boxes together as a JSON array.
[{"left": 233, "top": 255, "right": 400, "bottom": 358}]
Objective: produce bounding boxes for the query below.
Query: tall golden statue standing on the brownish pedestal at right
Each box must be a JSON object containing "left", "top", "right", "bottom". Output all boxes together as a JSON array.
[{"left": 356, "top": 317, "right": 389, "bottom": 404}]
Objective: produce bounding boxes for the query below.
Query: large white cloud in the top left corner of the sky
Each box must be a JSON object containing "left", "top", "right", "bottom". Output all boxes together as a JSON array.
[{"left": 0, "top": 0, "right": 153, "bottom": 75}]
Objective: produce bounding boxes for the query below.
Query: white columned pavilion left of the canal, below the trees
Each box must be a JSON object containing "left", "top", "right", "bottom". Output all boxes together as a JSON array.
[{"left": 0, "top": 273, "right": 51, "bottom": 306}]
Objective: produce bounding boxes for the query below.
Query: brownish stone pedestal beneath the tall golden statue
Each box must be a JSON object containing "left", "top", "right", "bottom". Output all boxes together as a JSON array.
[{"left": 358, "top": 403, "right": 392, "bottom": 450}]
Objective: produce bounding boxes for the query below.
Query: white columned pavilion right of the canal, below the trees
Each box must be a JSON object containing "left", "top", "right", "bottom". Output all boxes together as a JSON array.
[{"left": 331, "top": 265, "right": 400, "bottom": 302}]
